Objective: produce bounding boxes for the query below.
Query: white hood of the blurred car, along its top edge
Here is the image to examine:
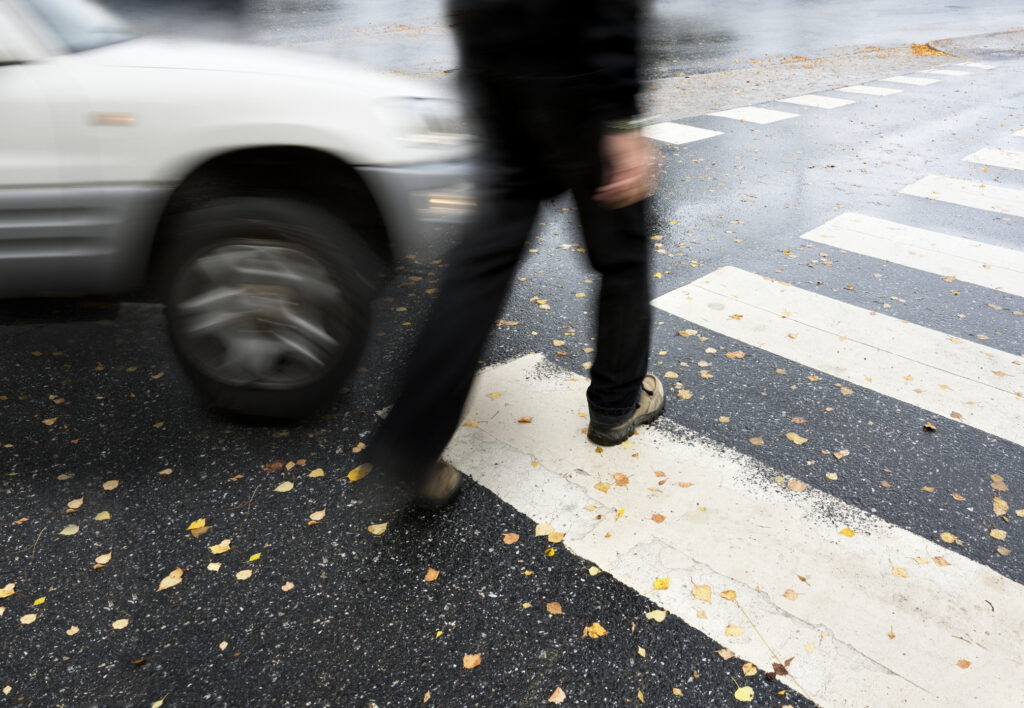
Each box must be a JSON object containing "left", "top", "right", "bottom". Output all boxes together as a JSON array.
[{"left": 80, "top": 37, "right": 453, "bottom": 98}]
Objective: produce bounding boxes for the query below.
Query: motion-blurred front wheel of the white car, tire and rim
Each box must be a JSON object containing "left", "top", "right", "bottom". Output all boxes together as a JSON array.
[{"left": 163, "top": 198, "right": 381, "bottom": 419}]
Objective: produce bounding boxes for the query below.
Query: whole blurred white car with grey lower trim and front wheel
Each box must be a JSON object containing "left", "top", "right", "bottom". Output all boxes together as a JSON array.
[{"left": 0, "top": 0, "right": 472, "bottom": 417}]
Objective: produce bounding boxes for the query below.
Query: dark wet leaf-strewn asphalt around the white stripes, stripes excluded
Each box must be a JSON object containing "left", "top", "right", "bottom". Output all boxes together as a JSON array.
[{"left": 0, "top": 5, "right": 1024, "bottom": 707}]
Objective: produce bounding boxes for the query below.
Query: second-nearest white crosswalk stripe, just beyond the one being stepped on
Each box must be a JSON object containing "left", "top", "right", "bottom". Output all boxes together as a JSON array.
[{"left": 653, "top": 266, "right": 1024, "bottom": 445}]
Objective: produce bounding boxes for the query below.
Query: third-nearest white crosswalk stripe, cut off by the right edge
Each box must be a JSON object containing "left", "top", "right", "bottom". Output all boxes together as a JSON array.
[{"left": 800, "top": 211, "right": 1024, "bottom": 299}]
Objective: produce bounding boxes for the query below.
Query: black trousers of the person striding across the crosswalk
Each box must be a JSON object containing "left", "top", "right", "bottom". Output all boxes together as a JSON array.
[{"left": 369, "top": 92, "right": 650, "bottom": 482}]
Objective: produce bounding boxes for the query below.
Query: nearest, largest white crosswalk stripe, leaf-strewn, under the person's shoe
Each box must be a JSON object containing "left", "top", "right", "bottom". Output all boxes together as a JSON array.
[{"left": 444, "top": 355, "right": 1024, "bottom": 708}]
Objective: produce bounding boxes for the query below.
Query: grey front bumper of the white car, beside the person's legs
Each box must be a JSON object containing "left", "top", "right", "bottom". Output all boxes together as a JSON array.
[{"left": 356, "top": 160, "right": 477, "bottom": 255}]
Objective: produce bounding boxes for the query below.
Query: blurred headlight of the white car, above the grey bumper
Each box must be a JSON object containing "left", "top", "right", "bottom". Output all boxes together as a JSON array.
[{"left": 377, "top": 97, "right": 470, "bottom": 148}]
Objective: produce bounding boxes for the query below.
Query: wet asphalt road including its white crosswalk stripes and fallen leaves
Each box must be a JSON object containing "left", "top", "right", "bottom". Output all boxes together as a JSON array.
[{"left": 6, "top": 5, "right": 1024, "bottom": 708}]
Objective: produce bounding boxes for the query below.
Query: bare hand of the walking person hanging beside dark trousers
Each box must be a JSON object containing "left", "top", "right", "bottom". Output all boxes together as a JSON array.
[{"left": 594, "top": 130, "right": 654, "bottom": 209}]
